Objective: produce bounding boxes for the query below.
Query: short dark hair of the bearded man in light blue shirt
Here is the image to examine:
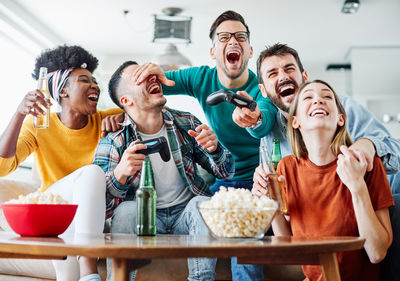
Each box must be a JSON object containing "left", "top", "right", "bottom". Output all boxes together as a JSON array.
[{"left": 257, "top": 43, "right": 304, "bottom": 84}]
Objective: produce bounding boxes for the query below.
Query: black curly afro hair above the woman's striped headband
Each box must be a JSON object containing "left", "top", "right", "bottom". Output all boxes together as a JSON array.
[{"left": 32, "top": 45, "right": 99, "bottom": 80}]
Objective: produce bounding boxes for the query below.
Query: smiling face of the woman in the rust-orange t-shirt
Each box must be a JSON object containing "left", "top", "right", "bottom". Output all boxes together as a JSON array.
[{"left": 292, "top": 83, "right": 344, "bottom": 132}]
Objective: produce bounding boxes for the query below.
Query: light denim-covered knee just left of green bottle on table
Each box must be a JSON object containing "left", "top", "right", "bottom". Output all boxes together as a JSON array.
[{"left": 111, "top": 201, "right": 136, "bottom": 233}]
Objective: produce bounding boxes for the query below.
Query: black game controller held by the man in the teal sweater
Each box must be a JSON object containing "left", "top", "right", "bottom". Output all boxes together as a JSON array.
[{"left": 206, "top": 89, "right": 257, "bottom": 111}]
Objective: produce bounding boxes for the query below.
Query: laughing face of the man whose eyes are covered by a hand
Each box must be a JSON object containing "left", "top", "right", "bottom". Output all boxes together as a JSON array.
[{"left": 118, "top": 64, "right": 167, "bottom": 110}]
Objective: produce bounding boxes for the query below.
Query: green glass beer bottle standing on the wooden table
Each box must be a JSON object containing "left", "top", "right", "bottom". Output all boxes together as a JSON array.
[{"left": 136, "top": 157, "right": 157, "bottom": 236}]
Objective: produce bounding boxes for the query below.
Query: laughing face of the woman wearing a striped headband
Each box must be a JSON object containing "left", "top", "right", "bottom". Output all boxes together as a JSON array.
[{"left": 61, "top": 68, "right": 100, "bottom": 115}]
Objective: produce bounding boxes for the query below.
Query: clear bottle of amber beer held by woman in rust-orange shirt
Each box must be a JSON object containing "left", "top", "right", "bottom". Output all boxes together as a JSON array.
[{"left": 260, "top": 144, "right": 287, "bottom": 214}]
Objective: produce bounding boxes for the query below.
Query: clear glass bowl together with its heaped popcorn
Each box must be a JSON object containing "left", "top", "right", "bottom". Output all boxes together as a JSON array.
[{"left": 197, "top": 187, "right": 278, "bottom": 238}]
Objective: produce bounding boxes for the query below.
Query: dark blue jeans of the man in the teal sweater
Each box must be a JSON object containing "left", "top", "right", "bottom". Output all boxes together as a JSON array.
[{"left": 210, "top": 180, "right": 264, "bottom": 281}]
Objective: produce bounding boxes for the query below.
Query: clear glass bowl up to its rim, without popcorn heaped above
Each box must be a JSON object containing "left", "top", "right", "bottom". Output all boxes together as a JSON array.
[{"left": 197, "top": 201, "right": 278, "bottom": 239}]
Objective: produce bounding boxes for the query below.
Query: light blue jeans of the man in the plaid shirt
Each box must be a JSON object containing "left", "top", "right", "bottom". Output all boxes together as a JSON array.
[{"left": 107, "top": 196, "right": 217, "bottom": 281}]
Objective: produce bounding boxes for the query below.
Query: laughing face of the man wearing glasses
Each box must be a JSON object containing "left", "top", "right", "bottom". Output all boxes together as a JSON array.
[{"left": 210, "top": 20, "right": 253, "bottom": 79}]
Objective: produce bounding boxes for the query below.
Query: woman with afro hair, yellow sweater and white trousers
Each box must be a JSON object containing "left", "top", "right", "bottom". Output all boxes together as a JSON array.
[{"left": 0, "top": 46, "right": 122, "bottom": 281}]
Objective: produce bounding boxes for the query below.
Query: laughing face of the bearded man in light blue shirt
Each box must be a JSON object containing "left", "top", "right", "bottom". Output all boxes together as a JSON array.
[{"left": 260, "top": 54, "right": 307, "bottom": 113}]
